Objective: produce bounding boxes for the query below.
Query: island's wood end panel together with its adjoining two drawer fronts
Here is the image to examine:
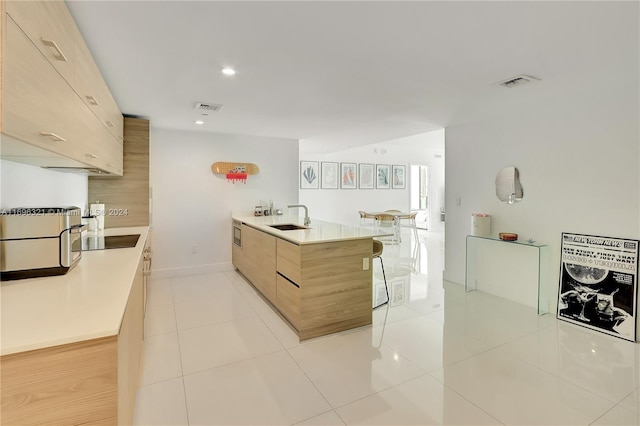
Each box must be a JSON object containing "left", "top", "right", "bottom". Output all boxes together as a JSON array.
[{"left": 275, "top": 239, "right": 373, "bottom": 340}]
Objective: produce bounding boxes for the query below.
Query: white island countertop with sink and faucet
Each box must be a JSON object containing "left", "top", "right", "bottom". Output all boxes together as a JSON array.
[{"left": 233, "top": 216, "right": 392, "bottom": 244}]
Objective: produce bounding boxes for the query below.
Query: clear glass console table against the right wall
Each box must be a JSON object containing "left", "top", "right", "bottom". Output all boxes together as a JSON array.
[{"left": 465, "top": 235, "right": 551, "bottom": 315}]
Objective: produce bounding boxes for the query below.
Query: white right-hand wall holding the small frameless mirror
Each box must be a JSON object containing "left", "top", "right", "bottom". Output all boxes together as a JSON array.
[{"left": 444, "top": 70, "right": 640, "bottom": 312}]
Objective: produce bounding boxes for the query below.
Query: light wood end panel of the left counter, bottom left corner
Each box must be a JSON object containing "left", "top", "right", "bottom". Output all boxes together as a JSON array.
[{"left": 0, "top": 336, "right": 118, "bottom": 425}]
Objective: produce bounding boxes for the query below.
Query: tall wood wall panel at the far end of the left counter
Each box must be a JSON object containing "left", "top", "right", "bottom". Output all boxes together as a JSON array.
[{"left": 89, "top": 117, "right": 149, "bottom": 228}]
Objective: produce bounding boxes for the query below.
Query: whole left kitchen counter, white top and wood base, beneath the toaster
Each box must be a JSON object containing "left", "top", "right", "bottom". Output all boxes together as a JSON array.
[{"left": 0, "top": 227, "right": 149, "bottom": 425}]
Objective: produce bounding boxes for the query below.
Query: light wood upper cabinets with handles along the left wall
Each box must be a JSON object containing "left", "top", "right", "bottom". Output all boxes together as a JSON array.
[{"left": 0, "top": 1, "right": 123, "bottom": 176}]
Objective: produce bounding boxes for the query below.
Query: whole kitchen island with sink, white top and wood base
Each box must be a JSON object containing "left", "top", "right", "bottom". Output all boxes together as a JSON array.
[{"left": 232, "top": 216, "right": 389, "bottom": 340}]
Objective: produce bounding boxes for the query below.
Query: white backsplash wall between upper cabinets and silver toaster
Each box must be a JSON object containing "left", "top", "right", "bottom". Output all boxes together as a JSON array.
[{"left": 0, "top": 160, "right": 88, "bottom": 213}]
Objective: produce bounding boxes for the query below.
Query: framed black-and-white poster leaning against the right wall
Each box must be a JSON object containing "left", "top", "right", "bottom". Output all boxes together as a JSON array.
[{"left": 557, "top": 232, "right": 640, "bottom": 342}]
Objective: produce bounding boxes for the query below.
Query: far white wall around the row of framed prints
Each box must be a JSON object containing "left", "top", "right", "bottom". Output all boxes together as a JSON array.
[{"left": 299, "top": 130, "right": 444, "bottom": 231}]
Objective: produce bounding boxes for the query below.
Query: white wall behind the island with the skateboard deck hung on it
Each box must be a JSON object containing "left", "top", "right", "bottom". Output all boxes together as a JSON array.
[{"left": 149, "top": 128, "right": 298, "bottom": 276}]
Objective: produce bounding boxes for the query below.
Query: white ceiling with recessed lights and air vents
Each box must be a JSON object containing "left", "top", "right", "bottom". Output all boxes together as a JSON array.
[{"left": 67, "top": 1, "right": 638, "bottom": 152}]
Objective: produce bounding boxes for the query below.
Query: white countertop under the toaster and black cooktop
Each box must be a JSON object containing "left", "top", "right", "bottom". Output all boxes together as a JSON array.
[{"left": 0, "top": 226, "right": 149, "bottom": 355}]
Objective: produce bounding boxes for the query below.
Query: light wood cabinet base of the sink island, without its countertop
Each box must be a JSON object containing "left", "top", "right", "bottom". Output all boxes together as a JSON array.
[{"left": 233, "top": 225, "right": 373, "bottom": 340}]
